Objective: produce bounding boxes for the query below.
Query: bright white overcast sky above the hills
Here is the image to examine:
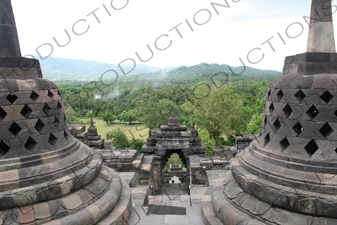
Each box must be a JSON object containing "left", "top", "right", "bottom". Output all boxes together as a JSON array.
[{"left": 12, "top": 0, "right": 337, "bottom": 71}]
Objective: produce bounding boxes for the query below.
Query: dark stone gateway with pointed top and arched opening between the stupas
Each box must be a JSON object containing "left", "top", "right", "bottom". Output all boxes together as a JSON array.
[{"left": 142, "top": 110, "right": 207, "bottom": 193}]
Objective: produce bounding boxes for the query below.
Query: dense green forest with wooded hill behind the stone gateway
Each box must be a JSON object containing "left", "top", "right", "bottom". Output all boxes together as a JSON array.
[{"left": 56, "top": 60, "right": 280, "bottom": 153}]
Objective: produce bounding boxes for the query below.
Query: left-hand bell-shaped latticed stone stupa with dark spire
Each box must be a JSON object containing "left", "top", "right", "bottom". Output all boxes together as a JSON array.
[{"left": 0, "top": 0, "right": 131, "bottom": 225}]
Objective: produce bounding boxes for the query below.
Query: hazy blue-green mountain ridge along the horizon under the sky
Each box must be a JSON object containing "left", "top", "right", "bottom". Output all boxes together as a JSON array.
[{"left": 40, "top": 57, "right": 281, "bottom": 83}]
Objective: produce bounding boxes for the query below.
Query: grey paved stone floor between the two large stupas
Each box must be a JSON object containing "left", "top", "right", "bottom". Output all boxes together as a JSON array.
[{"left": 128, "top": 170, "right": 228, "bottom": 225}]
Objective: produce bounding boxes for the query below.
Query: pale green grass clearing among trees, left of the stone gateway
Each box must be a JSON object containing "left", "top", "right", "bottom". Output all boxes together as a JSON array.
[{"left": 79, "top": 118, "right": 149, "bottom": 141}]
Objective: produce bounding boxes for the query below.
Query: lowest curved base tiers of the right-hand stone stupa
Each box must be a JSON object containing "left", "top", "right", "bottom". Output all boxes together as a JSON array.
[{"left": 202, "top": 171, "right": 337, "bottom": 225}]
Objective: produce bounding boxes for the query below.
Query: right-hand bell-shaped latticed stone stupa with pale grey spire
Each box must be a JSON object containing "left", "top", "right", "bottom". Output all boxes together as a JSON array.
[{"left": 203, "top": 0, "right": 337, "bottom": 225}]
